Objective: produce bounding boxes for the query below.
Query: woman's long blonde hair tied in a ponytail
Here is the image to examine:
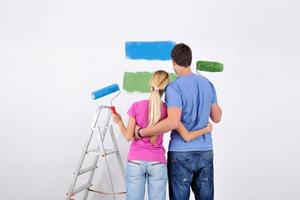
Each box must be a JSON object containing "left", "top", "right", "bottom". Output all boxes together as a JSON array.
[{"left": 148, "top": 70, "right": 170, "bottom": 126}]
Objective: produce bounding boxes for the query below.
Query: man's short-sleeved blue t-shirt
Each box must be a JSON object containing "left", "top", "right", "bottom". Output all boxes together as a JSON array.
[{"left": 165, "top": 73, "right": 217, "bottom": 151}]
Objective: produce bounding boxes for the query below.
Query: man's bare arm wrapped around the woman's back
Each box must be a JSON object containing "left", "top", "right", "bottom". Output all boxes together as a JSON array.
[{"left": 139, "top": 107, "right": 181, "bottom": 137}]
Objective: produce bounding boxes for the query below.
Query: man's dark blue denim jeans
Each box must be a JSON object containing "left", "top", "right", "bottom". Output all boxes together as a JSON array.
[{"left": 168, "top": 151, "right": 214, "bottom": 200}]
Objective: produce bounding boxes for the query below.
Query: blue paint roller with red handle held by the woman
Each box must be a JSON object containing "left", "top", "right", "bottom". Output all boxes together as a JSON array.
[{"left": 91, "top": 84, "right": 121, "bottom": 115}]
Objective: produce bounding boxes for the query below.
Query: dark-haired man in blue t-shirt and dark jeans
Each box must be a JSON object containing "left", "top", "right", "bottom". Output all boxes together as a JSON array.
[{"left": 136, "top": 43, "right": 222, "bottom": 200}]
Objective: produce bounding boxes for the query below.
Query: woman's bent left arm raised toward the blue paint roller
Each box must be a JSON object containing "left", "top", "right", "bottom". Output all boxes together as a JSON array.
[{"left": 112, "top": 114, "right": 136, "bottom": 142}]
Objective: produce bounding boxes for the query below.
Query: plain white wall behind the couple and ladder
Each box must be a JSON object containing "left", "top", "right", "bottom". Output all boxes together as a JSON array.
[{"left": 0, "top": 0, "right": 300, "bottom": 200}]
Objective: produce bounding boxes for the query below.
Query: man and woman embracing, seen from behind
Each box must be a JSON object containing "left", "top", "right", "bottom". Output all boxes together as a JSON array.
[{"left": 113, "top": 43, "right": 222, "bottom": 200}]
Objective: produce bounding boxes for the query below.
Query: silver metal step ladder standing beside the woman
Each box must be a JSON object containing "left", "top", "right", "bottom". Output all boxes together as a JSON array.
[{"left": 67, "top": 105, "right": 125, "bottom": 200}]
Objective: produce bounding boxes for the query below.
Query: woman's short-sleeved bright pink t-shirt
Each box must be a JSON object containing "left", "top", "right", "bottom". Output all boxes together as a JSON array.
[{"left": 127, "top": 100, "right": 167, "bottom": 163}]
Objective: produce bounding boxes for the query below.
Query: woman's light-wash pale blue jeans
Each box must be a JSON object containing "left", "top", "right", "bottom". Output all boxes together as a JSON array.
[{"left": 126, "top": 160, "right": 168, "bottom": 200}]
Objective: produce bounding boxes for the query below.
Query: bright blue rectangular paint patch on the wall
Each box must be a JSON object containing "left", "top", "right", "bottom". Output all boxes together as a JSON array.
[{"left": 125, "top": 41, "right": 175, "bottom": 60}]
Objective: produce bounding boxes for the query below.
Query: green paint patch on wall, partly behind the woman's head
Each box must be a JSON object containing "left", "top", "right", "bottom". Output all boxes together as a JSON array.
[{"left": 123, "top": 72, "right": 177, "bottom": 93}]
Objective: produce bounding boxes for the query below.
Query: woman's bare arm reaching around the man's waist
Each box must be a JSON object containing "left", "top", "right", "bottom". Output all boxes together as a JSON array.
[{"left": 176, "top": 122, "right": 212, "bottom": 142}]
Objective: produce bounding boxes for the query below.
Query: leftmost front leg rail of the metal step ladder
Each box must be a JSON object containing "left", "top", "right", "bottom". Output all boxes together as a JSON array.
[{"left": 67, "top": 130, "right": 94, "bottom": 200}]
